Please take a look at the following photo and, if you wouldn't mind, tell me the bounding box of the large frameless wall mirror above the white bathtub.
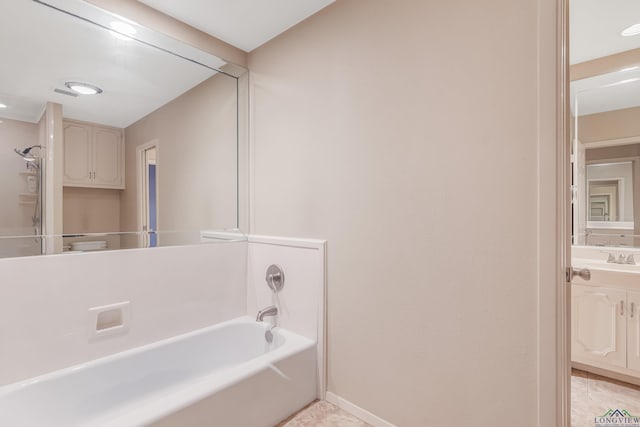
[0,0,246,257]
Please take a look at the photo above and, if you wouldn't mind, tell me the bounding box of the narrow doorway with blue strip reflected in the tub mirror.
[138,141,159,248]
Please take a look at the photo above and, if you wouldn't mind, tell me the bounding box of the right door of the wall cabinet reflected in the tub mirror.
[93,127,123,188]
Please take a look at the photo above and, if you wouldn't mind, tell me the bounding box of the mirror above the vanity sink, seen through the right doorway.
[571,37,640,247]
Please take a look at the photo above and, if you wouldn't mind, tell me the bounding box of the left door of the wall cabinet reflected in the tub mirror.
[63,123,93,186]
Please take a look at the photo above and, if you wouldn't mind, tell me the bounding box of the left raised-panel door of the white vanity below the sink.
[571,285,627,368]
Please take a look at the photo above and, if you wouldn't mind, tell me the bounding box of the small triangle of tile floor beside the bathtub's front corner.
[276,401,371,427]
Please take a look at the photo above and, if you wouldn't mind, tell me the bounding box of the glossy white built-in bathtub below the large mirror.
[0,317,317,427]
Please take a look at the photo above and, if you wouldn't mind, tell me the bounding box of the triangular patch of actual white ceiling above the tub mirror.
[138,0,335,52]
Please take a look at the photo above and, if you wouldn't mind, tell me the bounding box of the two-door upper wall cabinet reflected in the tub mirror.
[63,121,124,189]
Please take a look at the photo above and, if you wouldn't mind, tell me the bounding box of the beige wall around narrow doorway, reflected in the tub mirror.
[120,74,238,239]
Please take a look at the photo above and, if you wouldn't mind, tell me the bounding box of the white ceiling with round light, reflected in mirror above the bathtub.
[0,0,223,127]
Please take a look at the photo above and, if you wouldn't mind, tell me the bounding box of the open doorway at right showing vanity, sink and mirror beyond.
[562,0,640,427]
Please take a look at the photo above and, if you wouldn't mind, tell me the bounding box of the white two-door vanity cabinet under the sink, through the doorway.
[571,284,640,376]
